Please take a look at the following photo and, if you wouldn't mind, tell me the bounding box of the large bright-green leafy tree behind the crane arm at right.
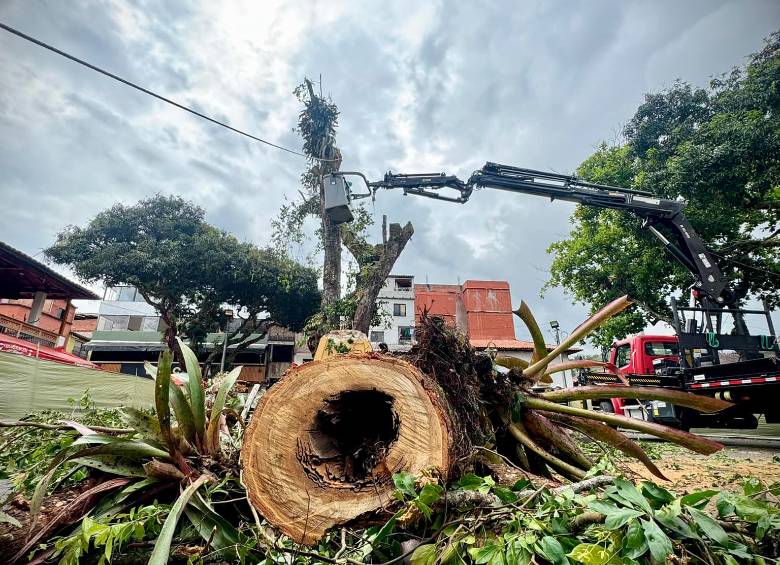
[546,33,780,346]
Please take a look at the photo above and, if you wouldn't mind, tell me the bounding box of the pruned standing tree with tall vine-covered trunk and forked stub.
[274,80,414,337]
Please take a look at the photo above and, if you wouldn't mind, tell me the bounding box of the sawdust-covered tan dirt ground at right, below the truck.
[621,444,780,493]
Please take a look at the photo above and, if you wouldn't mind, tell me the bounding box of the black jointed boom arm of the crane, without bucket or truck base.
[370,163,733,306]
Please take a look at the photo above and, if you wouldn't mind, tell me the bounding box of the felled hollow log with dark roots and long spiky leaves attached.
[241,298,731,545]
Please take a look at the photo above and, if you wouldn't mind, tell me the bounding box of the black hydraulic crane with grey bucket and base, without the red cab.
[324,162,780,426]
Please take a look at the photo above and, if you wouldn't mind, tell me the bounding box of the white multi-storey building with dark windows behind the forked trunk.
[368,275,414,351]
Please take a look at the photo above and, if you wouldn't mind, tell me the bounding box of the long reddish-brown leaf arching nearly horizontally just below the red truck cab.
[541,385,733,414]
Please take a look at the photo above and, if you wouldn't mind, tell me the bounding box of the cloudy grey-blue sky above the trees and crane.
[0,0,780,342]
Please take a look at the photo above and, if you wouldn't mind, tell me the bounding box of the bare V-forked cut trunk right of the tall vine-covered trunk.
[344,216,414,335]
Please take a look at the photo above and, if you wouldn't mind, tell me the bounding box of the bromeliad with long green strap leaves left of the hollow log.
[12,341,248,565]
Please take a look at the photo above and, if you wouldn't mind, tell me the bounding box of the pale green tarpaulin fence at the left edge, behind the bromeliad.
[0,353,154,420]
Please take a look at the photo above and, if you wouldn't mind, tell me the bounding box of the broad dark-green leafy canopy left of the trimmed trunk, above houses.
[46,195,319,366]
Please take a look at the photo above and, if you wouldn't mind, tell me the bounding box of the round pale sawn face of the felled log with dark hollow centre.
[241,354,456,544]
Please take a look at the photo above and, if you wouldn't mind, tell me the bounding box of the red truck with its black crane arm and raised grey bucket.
[322,162,780,428]
